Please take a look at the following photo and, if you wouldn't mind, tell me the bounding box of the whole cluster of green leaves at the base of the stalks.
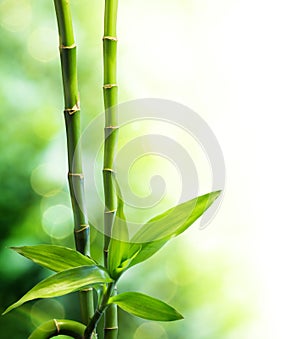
[3,189,220,321]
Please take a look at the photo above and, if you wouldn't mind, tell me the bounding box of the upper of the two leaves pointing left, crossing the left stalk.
[11,245,96,272]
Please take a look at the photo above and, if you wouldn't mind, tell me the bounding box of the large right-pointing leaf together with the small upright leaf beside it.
[108,191,221,278]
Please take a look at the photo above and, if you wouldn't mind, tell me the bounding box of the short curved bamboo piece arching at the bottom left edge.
[28,319,85,339]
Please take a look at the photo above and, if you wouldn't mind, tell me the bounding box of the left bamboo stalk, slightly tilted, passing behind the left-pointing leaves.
[54,0,94,324]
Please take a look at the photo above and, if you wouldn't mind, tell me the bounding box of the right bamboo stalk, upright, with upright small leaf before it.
[103,0,118,339]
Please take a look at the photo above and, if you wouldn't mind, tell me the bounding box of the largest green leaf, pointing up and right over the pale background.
[128,191,221,267]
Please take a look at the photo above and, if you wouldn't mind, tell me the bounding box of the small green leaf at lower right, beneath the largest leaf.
[109,292,183,321]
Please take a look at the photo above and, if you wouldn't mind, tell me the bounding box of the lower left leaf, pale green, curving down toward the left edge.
[3,266,112,314]
